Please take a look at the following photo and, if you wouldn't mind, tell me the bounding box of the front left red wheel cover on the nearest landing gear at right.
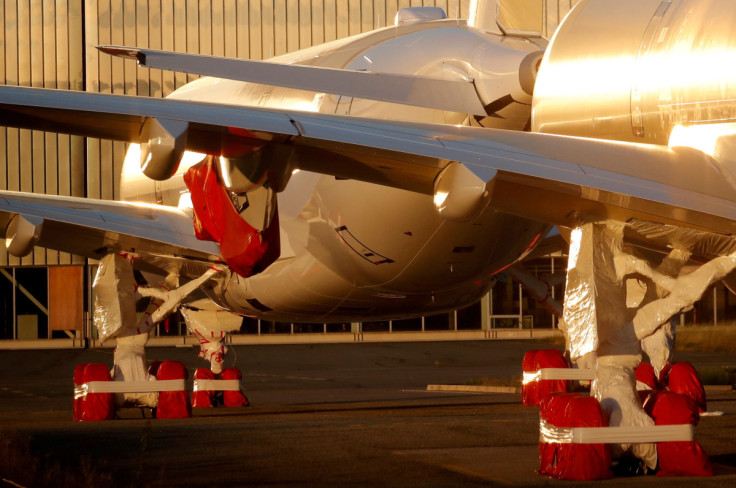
[539,393,613,480]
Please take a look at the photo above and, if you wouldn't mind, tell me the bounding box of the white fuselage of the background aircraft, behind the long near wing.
[121,21,549,322]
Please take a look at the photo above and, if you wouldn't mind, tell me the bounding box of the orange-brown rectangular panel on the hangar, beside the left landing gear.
[49,266,84,330]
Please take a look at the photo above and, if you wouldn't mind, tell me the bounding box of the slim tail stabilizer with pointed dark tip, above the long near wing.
[98,46,487,115]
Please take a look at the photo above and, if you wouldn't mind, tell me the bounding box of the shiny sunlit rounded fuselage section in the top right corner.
[532,0,736,144]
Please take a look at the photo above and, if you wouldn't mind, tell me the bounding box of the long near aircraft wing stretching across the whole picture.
[0,86,736,260]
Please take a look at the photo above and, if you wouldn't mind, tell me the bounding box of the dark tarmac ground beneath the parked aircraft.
[0,341,736,487]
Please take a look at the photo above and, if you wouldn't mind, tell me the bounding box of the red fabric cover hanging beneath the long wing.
[184,157,281,278]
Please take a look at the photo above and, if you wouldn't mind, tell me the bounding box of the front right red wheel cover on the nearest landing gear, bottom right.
[644,391,713,476]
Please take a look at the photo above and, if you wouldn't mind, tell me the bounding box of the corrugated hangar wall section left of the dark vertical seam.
[0,0,84,265]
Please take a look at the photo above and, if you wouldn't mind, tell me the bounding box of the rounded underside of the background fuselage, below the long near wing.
[216,173,548,322]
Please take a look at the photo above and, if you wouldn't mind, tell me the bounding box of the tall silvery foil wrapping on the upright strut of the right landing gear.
[564,221,657,468]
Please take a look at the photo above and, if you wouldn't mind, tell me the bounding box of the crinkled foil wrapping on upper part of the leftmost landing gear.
[92,254,137,342]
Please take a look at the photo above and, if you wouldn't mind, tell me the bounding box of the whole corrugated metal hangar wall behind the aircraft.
[0,0,577,266]
